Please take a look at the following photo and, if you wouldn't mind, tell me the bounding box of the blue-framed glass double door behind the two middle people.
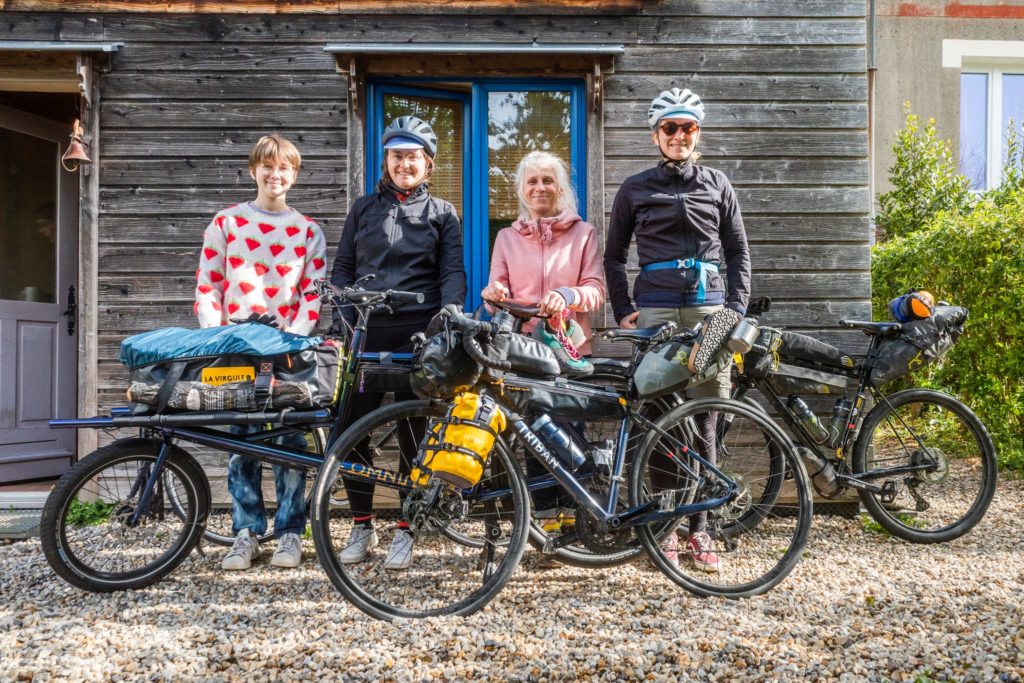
[365,78,587,307]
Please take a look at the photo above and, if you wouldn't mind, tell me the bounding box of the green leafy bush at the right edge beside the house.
[871,117,1024,471]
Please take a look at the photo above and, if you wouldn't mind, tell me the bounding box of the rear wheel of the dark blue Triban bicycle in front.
[630,398,811,598]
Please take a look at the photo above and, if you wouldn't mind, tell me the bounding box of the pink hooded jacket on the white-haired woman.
[487,213,605,354]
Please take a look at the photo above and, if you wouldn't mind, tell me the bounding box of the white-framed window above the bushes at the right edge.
[959,67,1024,190]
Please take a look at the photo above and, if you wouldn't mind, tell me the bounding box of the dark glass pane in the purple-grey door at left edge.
[0,128,59,303]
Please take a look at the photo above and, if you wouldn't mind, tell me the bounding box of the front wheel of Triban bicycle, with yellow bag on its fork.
[311,400,529,620]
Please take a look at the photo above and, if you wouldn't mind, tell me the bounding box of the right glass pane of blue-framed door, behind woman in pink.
[487,90,571,253]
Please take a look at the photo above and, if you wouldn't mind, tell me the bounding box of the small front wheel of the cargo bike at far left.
[39,438,210,593]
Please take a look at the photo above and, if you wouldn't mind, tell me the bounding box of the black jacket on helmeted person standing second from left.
[331,184,466,326]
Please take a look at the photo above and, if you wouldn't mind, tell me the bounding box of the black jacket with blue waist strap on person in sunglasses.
[604,163,751,321]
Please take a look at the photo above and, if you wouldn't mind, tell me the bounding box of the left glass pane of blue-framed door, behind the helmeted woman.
[383,93,463,218]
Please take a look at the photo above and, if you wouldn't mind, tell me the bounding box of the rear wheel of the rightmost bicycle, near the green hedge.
[853,389,996,543]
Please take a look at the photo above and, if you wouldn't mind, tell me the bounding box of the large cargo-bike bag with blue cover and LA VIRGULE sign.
[120,323,342,414]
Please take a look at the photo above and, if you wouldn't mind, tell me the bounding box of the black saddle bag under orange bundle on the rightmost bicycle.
[871,305,968,386]
